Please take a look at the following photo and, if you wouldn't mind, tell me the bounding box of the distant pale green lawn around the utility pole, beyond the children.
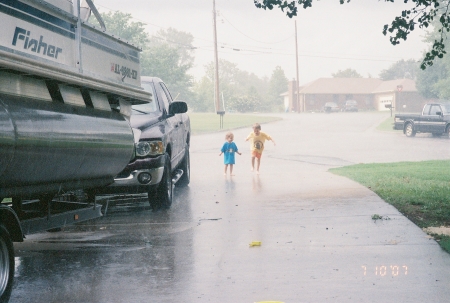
[189,113,282,135]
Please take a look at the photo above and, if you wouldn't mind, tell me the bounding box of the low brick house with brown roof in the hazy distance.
[281,78,427,112]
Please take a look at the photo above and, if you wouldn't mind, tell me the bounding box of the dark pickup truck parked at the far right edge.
[394,103,450,137]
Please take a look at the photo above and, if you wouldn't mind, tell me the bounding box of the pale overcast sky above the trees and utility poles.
[95,0,427,84]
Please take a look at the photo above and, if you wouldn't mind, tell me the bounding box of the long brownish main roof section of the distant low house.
[300,78,383,94]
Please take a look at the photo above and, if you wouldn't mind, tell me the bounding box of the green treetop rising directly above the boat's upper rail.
[96,11,149,47]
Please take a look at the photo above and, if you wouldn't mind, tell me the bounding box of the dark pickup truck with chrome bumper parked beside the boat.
[91,76,191,209]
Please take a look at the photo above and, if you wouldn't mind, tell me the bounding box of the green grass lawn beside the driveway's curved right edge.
[330,160,450,252]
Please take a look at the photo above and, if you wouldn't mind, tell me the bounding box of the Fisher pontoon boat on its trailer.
[0,0,154,302]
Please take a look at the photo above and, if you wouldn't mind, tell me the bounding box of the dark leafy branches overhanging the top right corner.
[253,0,450,69]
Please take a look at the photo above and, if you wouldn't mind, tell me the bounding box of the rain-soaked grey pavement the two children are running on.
[11,113,450,303]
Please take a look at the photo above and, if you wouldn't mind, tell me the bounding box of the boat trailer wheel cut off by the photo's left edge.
[0,225,15,302]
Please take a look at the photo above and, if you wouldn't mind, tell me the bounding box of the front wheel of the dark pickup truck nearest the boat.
[148,153,173,210]
